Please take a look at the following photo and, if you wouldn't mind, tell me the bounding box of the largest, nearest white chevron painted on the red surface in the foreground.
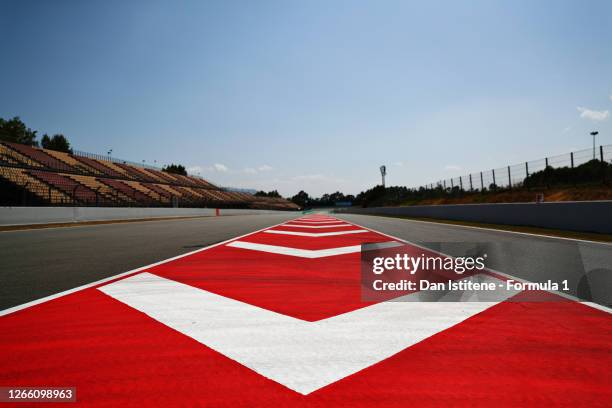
[98,273,513,395]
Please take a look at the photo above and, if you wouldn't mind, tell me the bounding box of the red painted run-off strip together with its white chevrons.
[0,214,612,407]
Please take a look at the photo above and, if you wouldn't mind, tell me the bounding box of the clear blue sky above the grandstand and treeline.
[0,0,612,195]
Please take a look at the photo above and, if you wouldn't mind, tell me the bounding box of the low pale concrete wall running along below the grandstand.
[0,207,296,226]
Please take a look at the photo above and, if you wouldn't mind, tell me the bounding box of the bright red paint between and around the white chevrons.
[0,217,612,407]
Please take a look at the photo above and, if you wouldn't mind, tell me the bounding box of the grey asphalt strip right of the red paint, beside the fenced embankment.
[340,214,612,306]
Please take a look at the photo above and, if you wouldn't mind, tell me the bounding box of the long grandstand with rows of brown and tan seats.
[0,141,298,210]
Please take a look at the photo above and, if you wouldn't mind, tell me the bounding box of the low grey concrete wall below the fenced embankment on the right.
[337,201,612,233]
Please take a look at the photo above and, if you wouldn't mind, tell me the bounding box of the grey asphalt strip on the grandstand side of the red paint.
[0,214,296,310]
